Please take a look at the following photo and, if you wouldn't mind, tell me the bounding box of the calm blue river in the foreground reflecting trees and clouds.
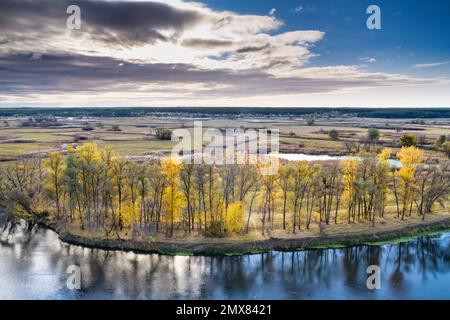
[0,222,450,299]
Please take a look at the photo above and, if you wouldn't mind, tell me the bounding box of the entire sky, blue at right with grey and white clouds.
[0,0,450,107]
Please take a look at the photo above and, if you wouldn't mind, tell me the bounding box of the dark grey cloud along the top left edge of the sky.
[0,0,203,45]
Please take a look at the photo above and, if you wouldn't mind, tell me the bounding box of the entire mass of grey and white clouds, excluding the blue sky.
[0,0,441,106]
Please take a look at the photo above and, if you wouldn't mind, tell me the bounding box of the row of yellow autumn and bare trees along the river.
[0,142,450,238]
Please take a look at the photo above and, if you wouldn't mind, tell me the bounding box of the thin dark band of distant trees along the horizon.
[0,107,450,119]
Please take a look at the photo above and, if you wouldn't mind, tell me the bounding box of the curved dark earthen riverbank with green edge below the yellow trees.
[39,216,450,256]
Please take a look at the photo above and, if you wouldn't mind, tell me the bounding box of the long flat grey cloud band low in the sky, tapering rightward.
[0,54,427,97]
